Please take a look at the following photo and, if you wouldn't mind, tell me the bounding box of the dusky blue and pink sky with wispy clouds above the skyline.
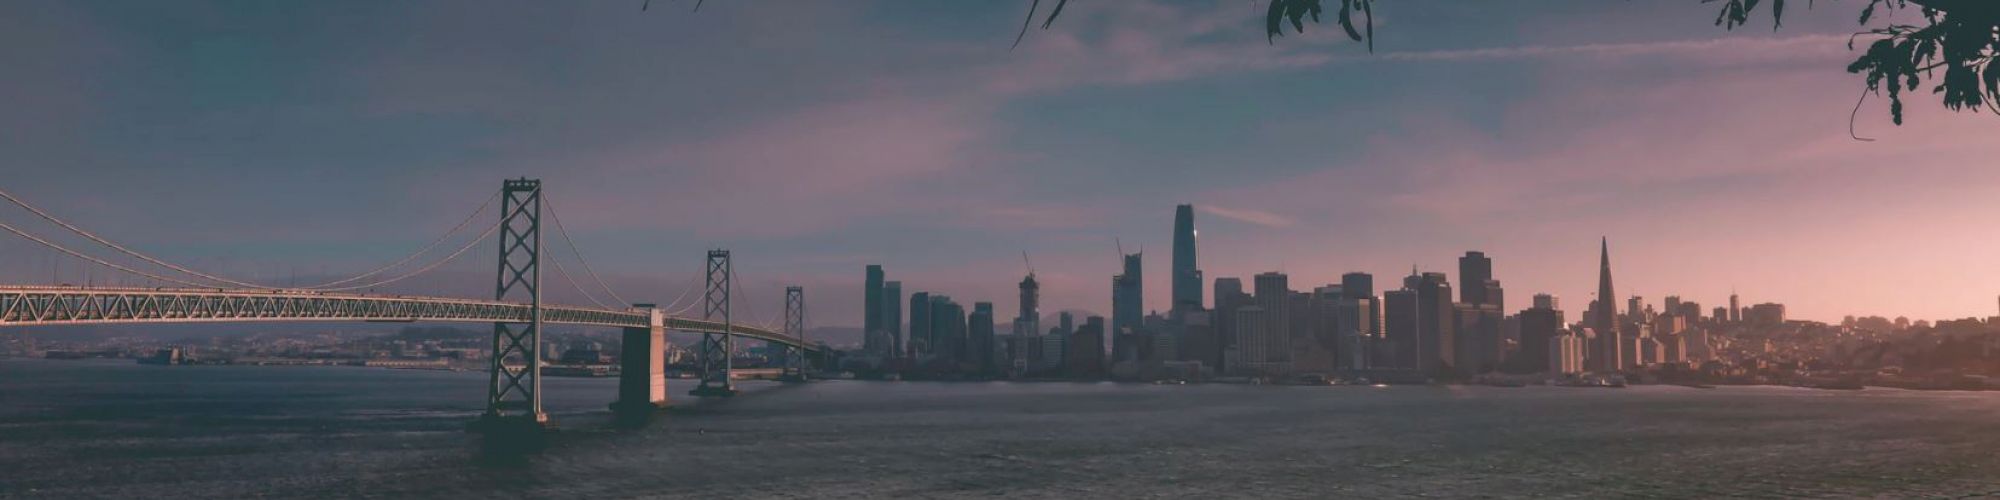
[0,0,2000,326]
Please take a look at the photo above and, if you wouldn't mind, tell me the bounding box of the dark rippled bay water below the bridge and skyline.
[0,360,2000,498]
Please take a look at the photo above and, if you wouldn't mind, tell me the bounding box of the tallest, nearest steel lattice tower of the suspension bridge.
[480,178,548,430]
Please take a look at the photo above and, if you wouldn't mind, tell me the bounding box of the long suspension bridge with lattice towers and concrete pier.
[0,178,822,430]
